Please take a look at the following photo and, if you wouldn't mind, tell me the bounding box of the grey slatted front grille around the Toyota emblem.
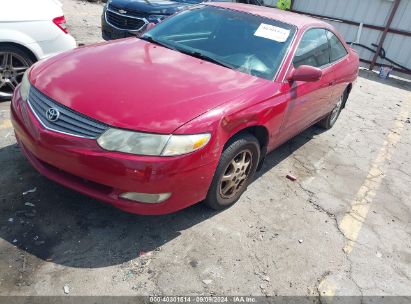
[28,86,108,138]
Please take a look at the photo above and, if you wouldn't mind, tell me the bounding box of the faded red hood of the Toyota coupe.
[29,38,273,133]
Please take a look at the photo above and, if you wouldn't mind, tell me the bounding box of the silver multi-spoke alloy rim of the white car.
[0,52,31,98]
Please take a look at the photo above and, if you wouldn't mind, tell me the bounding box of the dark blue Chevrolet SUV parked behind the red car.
[101,0,263,40]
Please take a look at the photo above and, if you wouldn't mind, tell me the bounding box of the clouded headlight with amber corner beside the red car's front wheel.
[97,129,210,156]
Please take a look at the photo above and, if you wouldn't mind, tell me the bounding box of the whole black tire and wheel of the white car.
[0,45,35,101]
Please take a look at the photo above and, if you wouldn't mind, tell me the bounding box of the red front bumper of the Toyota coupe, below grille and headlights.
[11,89,218,214]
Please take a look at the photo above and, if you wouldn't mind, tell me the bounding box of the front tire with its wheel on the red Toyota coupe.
[204,133,260,210]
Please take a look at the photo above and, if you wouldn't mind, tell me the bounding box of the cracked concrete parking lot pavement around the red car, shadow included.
[0,0,411,300]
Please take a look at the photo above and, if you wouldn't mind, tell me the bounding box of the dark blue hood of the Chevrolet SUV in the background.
[110,0,192,15]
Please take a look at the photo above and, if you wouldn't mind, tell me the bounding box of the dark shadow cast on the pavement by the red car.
[0,127,321,268]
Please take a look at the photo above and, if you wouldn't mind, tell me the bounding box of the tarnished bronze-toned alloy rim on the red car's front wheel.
[219,150,253,199]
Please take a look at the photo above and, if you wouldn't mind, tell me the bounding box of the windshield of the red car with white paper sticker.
[142,5,296,80]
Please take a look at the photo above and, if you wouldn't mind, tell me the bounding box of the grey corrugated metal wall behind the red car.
[266,0,411,73]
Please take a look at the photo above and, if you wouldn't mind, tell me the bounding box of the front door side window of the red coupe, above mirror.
[293,29,330,68]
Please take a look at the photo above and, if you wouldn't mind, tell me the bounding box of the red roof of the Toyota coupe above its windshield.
[207,2,334,30]
